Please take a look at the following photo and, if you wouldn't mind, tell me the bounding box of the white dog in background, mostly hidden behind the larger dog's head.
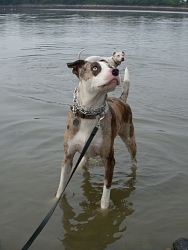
[78,49,125,68]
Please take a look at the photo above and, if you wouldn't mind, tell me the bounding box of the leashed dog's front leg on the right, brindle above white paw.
[101,152,115,209]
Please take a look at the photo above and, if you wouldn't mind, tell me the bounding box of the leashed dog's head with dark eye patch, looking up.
[67,60,120,92]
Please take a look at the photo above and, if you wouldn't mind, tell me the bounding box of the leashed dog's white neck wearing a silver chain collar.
[72,86,107,116]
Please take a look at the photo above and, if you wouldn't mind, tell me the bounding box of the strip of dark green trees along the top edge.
[0,0,188,6]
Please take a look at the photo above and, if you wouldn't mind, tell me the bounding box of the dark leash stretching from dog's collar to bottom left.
[21,116,104,250]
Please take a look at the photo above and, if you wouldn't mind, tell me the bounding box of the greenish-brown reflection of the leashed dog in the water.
[59,168,136,250]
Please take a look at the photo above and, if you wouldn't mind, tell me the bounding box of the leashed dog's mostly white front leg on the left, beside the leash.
[56,154,73,198]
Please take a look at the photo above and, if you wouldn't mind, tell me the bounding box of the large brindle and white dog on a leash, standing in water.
[56,60,137,209]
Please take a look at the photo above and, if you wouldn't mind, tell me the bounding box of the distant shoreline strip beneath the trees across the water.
[0,4,188,12]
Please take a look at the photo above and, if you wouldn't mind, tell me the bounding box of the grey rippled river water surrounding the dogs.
[0,8,188,250]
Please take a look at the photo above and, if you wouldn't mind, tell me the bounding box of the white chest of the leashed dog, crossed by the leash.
[68,119,103,157]
